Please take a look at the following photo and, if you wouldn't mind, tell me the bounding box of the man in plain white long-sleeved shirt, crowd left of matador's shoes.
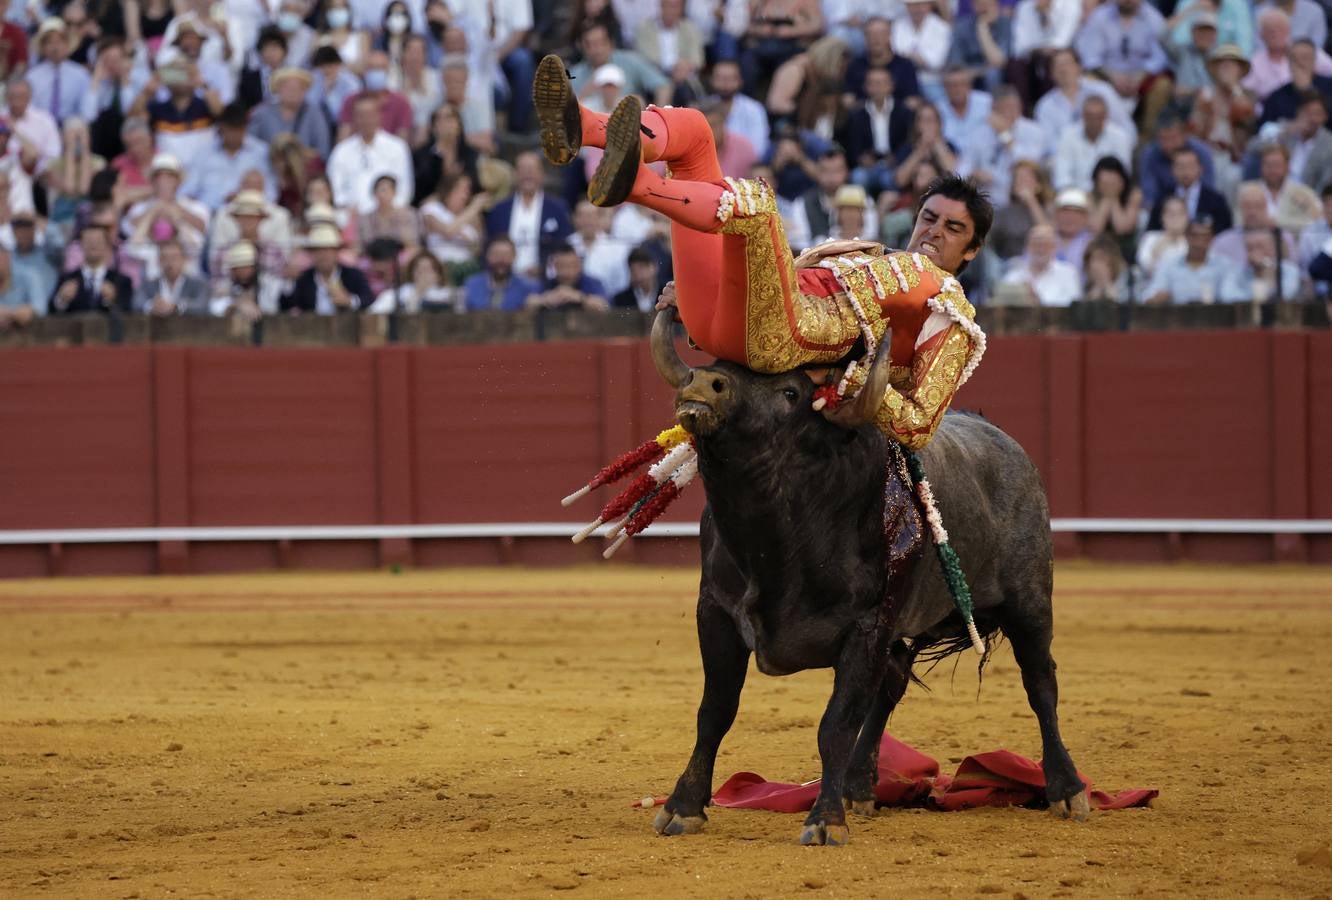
[328,93,414,213]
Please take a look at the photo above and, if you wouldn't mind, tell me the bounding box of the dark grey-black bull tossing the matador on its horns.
[653,310,1087,844]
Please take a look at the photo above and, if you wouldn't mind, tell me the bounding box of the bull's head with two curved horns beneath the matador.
[651,309,890,438]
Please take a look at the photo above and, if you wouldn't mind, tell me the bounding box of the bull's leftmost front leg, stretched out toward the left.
[653,602,750,835]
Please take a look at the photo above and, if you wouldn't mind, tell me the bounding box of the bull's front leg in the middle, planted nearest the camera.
[801,635,882,845]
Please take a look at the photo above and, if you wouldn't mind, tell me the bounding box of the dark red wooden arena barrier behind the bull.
[0,332,1332,576]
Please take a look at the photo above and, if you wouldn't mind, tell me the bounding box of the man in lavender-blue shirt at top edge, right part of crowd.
[1076,0,1172,126]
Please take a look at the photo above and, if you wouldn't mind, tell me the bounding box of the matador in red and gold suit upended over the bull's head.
[534,56,994,449]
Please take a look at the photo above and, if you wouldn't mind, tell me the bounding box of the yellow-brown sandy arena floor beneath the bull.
[0,564,1332,899]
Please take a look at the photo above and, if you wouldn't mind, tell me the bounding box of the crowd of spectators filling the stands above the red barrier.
[0,0,1332,328]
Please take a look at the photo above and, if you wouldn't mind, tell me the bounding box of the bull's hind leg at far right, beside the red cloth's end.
[1003,614,1090,821]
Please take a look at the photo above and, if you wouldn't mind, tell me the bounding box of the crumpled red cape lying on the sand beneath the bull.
[658,735,1159,812]
